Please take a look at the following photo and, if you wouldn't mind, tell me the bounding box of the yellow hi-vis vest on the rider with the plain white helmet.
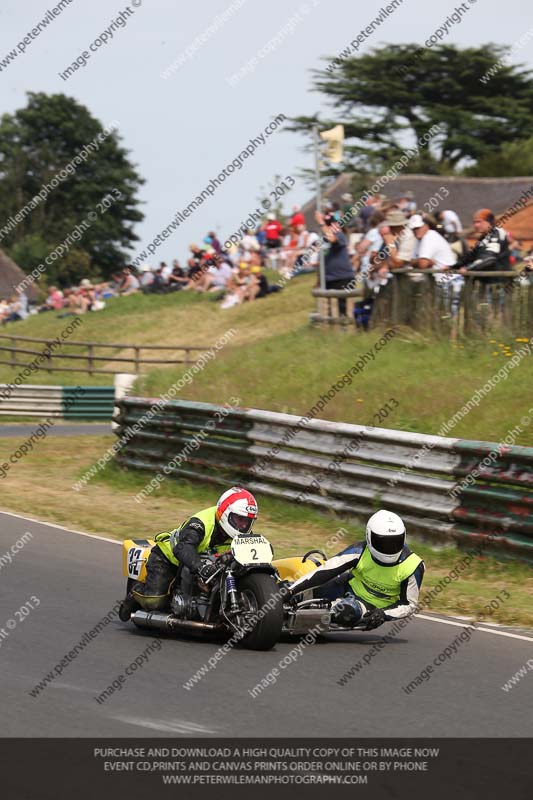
[350,547,422,608]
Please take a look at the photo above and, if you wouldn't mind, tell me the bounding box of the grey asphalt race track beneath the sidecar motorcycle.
[0,513,533,737]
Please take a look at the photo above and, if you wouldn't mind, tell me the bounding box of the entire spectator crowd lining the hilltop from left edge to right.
[0,192,533,329]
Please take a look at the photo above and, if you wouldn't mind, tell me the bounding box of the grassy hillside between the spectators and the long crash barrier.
[0,276,533,445]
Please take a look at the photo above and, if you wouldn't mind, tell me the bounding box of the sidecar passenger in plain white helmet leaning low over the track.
[289,510,424,630]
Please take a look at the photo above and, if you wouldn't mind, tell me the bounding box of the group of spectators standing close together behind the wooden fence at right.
[315,192,533,330]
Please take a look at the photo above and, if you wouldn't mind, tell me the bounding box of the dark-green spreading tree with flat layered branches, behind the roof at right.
[292,44,533,174]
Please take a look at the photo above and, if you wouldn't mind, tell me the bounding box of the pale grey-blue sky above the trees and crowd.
[0,0,533,264]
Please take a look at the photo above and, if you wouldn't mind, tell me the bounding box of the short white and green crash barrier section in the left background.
[0,384,115,420]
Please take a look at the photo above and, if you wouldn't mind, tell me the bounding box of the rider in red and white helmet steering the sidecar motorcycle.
[119,486,257,622]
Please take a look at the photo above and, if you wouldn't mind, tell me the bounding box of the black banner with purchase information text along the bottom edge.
[0,738,533,800]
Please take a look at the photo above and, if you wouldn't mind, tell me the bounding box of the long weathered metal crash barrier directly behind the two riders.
[114,397,533,559]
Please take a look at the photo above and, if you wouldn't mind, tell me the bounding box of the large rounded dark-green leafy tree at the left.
[0,93,144,285]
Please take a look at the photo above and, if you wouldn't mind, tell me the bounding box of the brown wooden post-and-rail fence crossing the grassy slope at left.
[0,333,208,375]
